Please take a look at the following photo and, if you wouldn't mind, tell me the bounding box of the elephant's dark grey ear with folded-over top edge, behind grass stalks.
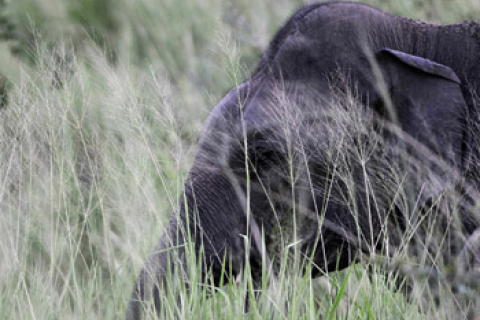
[375,49,466,201]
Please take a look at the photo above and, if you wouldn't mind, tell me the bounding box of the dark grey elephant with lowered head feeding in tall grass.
[127,2,480,320]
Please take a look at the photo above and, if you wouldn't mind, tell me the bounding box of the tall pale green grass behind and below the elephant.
[0,0,480,320]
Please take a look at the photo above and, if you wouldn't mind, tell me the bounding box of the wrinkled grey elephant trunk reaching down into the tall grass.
[127,167,253,320]
